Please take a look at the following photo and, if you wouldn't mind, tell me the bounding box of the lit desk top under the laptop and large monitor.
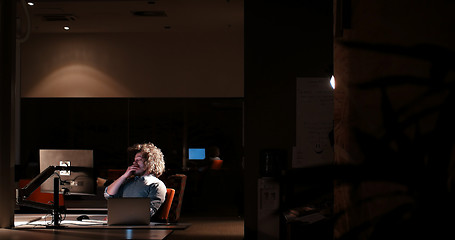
[12,214,190,240]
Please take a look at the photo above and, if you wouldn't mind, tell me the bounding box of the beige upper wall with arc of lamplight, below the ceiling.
[21,29,243,97]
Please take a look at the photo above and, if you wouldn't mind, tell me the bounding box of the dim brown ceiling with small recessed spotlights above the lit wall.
[17,0,243,33]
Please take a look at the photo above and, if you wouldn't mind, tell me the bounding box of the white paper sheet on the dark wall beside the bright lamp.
[292,78,333,168]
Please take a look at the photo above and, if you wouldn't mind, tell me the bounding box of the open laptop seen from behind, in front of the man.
[107,198,150,225]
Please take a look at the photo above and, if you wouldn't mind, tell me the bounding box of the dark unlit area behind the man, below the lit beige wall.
[15,98,243,216]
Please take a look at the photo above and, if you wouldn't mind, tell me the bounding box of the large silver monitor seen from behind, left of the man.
[39,149,96,195]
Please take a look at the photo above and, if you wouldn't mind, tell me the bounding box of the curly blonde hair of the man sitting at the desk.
[128,142,165,177]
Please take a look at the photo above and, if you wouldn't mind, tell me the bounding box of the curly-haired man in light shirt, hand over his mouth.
[104,143,166,217]
